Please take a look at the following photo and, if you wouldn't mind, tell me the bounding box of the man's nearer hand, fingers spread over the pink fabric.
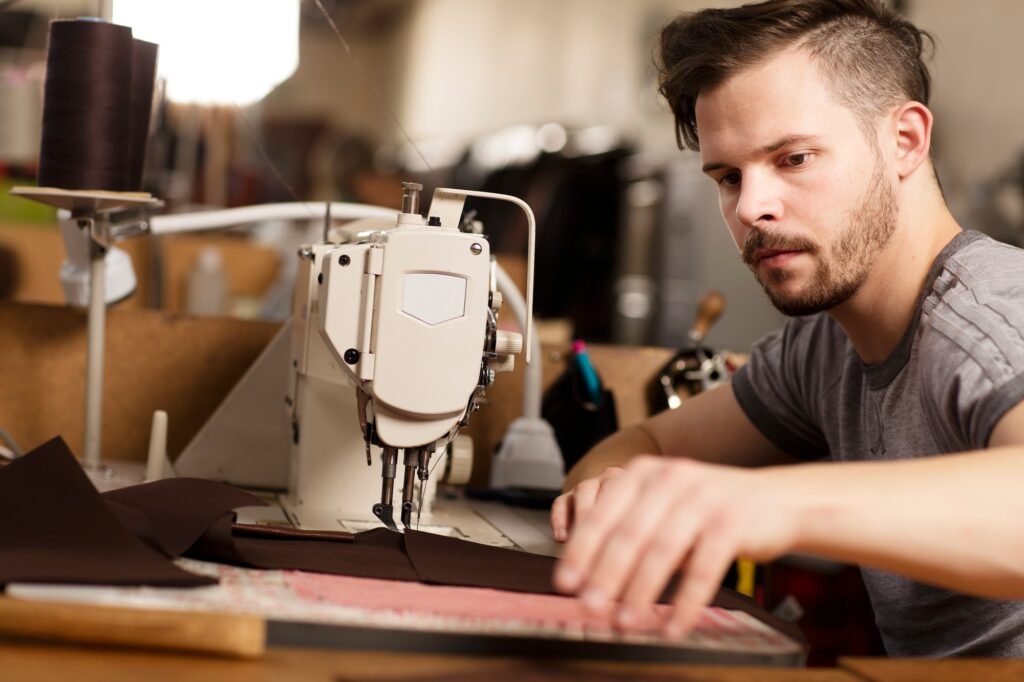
[552,457,801,637]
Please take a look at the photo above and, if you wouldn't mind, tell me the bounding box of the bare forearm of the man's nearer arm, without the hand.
[774,447,1024,598]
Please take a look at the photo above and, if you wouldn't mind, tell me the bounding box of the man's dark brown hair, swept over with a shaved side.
[656,0,934,150]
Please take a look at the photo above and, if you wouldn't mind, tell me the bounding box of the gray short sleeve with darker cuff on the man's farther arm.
[732,318,828,460]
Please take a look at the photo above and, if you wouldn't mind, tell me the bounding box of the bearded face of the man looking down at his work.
[696,49,897,315]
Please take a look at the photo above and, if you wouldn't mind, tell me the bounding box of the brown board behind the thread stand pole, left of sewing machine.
[0,303,279,460]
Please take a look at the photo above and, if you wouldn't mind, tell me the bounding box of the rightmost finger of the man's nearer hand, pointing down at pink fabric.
[665,526,735,639]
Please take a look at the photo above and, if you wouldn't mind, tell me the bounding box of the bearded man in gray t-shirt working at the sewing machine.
[552,0,1024,656]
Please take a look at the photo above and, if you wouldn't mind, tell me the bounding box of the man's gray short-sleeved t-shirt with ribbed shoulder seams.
[733,231,1024,656]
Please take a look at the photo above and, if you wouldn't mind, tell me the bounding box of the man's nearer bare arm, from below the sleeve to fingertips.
[555,403,1024,635]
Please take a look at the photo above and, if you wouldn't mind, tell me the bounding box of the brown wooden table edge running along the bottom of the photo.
[0,640,1024,682]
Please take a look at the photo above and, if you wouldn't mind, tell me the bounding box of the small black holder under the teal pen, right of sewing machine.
[541,356,618,471]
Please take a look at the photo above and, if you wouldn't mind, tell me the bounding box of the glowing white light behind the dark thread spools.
[113,0,299,105]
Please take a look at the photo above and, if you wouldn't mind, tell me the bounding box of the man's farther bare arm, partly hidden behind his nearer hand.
[551,384,796,542]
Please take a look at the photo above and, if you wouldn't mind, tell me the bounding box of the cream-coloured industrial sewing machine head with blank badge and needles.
[290,183,523,528]
